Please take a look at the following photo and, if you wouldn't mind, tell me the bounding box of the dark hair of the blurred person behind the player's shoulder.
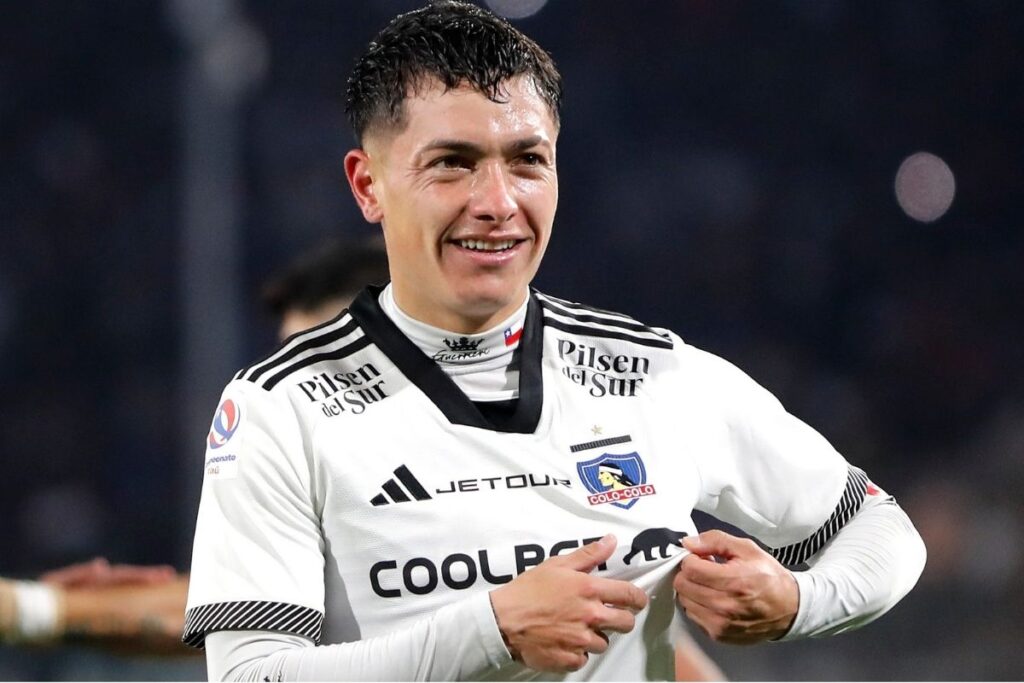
[261,240,389,317]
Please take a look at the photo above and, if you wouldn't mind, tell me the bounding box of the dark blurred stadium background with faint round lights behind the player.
[0,0,1024,680]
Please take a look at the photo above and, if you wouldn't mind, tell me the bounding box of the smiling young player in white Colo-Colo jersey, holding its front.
[185,2,925,680]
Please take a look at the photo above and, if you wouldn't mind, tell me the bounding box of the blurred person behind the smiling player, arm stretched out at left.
[0,239,388,655]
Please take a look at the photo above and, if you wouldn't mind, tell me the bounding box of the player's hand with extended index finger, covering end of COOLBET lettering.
[490,535,647,672]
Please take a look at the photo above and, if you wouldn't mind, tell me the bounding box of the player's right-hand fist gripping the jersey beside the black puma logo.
[673,529,800,645]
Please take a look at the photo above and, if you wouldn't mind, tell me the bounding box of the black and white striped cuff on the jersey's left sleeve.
[181,600,324,649]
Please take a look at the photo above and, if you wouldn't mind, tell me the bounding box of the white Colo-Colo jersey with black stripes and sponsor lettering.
[184,290,920,680]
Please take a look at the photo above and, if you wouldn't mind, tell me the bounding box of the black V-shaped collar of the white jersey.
[348,285,544,434]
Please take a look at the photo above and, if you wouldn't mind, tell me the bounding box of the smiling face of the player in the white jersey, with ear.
[345,77,558,334]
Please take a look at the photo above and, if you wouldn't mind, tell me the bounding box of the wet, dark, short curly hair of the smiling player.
[345,0,562,145]
